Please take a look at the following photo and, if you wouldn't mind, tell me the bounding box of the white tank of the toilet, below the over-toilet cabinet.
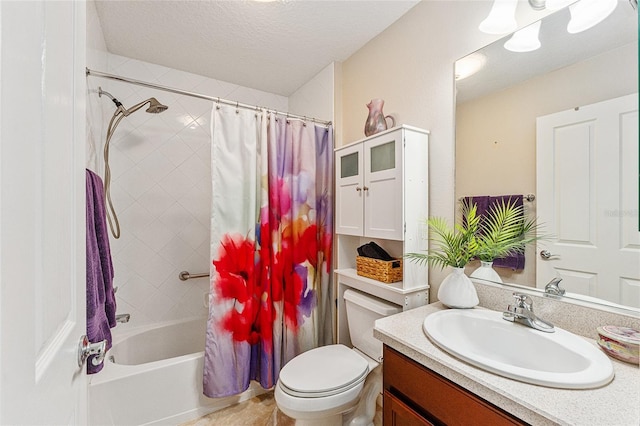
[344,289,402,361]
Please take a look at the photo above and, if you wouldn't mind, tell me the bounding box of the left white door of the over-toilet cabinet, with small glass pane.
[336,143,364,236]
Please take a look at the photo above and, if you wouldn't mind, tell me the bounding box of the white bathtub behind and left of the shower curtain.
[89,317,265,426]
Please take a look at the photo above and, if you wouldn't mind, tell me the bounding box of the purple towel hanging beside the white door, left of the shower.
[86,170,116,374]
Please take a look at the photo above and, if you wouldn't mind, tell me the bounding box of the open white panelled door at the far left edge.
[0,1,87,425]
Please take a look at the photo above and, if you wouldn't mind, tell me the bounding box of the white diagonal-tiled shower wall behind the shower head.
[88,54,288,328]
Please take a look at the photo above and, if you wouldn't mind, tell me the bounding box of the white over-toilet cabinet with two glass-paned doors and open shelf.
[335,125,429,345]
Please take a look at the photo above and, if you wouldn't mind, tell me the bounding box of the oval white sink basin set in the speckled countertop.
[422,309,613,389]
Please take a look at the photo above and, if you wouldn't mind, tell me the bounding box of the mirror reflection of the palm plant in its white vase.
[471,199,542,282]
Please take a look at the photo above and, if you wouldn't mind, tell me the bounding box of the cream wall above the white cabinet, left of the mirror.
[336,0,548,301]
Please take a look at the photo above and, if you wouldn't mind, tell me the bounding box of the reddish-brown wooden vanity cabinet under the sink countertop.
[382,345,527,426]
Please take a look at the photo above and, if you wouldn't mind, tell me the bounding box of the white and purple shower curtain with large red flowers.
[204,105,333,397]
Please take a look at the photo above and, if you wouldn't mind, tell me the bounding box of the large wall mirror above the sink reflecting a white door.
[456,1,640,311]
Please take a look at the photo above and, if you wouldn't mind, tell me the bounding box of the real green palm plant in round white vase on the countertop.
[406,203,480,308]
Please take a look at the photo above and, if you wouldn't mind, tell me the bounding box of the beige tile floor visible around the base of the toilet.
[181,392,382,426]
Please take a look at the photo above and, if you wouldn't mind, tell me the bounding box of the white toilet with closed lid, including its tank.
[274,289,402,426]
